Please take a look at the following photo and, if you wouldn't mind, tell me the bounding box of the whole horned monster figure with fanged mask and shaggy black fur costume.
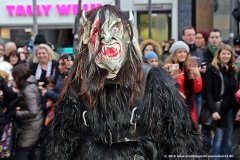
[41,5,203,160]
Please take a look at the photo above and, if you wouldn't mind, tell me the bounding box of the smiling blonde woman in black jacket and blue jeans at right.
[204,45,238,160]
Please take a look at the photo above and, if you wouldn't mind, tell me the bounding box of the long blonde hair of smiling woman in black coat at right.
[211,44,238,74]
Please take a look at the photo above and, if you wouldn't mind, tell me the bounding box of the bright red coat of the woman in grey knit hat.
[176,71,202,123]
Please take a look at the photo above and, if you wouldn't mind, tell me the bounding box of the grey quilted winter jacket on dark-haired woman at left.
[16,75,44,147]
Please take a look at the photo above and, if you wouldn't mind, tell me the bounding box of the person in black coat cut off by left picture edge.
[0,75,12,138]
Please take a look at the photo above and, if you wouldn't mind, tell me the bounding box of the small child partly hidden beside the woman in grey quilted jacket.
[43,76,56,126]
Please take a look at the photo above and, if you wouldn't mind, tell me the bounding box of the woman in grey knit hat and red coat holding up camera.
[163,41,202,123]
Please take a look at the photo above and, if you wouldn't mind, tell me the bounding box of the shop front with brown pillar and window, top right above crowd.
[195,0,239,44]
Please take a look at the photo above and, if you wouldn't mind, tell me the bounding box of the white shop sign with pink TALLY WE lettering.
[0,0,109,25]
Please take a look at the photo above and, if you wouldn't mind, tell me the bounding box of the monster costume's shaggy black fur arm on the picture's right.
[141,68,203,159]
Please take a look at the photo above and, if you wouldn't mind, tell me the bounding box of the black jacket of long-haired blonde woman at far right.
[204,64,237,128]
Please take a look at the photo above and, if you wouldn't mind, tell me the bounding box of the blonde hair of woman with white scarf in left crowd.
[33,44,56,63]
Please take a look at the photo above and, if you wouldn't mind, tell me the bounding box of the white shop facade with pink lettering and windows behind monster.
[0,0,182,51]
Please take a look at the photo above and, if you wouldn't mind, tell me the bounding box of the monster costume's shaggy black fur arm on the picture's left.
[40,79,83,160]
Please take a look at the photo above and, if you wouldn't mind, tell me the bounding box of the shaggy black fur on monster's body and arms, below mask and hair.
[41,68,204,160]
